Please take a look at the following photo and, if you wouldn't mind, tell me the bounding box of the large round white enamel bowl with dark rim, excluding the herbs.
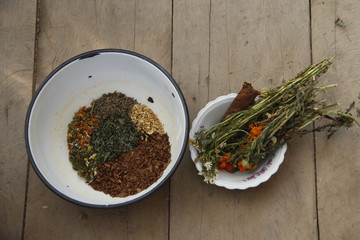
[25,49,189,208]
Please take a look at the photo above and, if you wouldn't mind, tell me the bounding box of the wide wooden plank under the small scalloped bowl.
[170,1,317,239]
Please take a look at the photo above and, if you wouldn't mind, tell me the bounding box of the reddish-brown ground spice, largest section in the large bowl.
[90,133,171,197]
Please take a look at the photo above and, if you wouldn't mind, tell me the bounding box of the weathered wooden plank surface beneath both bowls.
[0,0,360,240]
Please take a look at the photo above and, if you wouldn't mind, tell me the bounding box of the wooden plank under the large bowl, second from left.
[25,0,172,240]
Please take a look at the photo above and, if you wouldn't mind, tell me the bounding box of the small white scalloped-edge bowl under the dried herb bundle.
[189,93,287,190]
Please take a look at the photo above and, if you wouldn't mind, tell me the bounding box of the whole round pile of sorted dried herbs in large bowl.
[67,92,171,197]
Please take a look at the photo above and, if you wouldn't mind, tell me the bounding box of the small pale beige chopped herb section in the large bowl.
[130,104,165,134]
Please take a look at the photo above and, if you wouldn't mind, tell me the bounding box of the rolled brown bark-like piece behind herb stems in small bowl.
[221,82,260,121]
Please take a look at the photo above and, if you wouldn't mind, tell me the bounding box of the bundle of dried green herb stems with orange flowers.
[190,59,360,183]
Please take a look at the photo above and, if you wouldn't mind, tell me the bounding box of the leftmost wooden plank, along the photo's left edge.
[0,0,36,239]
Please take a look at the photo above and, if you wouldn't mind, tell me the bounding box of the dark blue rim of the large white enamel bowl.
[24,48,190,208]
